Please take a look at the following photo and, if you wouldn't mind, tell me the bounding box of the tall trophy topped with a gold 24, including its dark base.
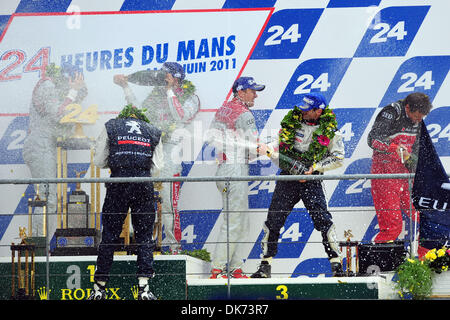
[52,104,100,255]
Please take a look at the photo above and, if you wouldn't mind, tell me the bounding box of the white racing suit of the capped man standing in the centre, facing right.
[208,97,258,272]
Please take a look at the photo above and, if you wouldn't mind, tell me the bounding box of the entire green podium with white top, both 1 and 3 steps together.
[0,255,404,301]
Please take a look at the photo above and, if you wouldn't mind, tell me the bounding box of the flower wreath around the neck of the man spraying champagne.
[279,106,337,165]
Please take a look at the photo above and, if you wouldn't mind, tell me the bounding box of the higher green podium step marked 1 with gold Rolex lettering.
[0,255,210,300]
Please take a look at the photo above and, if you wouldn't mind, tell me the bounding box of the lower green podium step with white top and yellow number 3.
[187,276,395,300]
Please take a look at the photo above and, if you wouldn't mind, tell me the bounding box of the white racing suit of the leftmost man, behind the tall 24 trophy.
[23,78,87,238]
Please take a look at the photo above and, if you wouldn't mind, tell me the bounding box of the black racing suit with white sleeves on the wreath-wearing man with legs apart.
[262,121,345,262]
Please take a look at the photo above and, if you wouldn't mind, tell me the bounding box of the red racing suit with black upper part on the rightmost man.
[367,100,420,243]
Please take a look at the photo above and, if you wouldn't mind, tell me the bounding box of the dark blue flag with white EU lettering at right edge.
[413,121,450,249]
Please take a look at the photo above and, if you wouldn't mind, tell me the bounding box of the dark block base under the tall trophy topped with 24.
[51,228,100,256]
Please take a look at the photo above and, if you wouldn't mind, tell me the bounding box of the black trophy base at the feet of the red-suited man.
[358,241,406,276]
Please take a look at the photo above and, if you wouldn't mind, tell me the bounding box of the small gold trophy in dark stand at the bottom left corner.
[10,228,36,300]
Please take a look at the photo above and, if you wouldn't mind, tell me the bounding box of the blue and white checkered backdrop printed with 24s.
[0,0,450,273]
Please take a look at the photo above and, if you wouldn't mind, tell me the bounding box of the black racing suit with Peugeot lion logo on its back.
[94,118,161,282]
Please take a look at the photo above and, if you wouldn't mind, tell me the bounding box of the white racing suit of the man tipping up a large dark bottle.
[124,86,200,251]
